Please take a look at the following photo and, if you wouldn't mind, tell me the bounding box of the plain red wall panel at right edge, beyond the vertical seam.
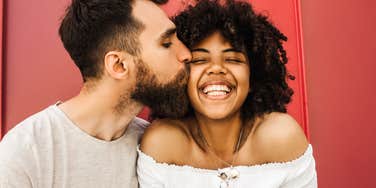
[302,0,376,188]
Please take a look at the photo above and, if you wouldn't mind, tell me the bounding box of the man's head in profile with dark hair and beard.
[59,0,191,117]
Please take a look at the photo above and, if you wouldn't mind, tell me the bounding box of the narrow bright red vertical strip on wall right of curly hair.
[294,0,310,139]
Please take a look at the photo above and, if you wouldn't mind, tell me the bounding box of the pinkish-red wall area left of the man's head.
[2,0,81,133]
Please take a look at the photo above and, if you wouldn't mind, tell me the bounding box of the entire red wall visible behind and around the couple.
[0,0,376,188]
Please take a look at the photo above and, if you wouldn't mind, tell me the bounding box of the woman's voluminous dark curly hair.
[173,0,294,120]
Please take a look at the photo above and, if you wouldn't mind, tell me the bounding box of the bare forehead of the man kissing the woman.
[132,0,175,33]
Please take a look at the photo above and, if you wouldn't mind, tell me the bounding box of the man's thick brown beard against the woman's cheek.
[131,60,189,119]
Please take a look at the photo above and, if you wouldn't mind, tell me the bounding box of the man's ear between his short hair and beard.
[104,51,132,79]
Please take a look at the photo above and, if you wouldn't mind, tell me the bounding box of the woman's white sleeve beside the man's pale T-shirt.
[137,149,166,188]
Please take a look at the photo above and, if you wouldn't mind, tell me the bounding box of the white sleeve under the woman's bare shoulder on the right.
[281,146,317,188]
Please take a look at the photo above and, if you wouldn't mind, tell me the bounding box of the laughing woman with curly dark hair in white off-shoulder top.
[138,1,317,188]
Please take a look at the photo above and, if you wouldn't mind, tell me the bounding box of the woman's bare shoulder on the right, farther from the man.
[252,112,308,162]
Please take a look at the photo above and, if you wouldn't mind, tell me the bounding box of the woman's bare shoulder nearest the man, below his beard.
[140,119,190,164]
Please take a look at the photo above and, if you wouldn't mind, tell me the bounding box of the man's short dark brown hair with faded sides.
[59,0,168,82]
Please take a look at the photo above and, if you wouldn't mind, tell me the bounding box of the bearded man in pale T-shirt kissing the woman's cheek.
[0,0,191,188]
